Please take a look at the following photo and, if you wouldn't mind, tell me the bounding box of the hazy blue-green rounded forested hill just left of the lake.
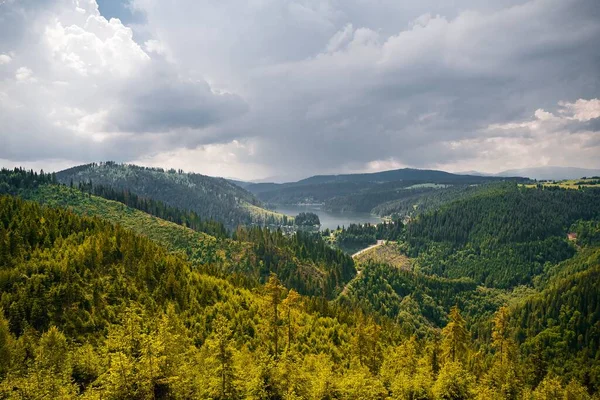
[56,162,283,228]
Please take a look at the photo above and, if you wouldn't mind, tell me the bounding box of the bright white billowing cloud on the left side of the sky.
[0,0,246,162]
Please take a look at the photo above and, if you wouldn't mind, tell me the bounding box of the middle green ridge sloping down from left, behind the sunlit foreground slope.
[0,170,356,298]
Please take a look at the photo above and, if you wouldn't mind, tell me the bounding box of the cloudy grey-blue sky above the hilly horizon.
[0,0,600,180]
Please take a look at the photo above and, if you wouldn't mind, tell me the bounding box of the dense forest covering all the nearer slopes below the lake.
[0,166,600,400]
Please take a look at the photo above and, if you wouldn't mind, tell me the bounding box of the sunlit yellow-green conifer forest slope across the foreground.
[0,196,600,400]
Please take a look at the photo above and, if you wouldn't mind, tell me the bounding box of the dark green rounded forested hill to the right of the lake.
[406,184,600,287]
